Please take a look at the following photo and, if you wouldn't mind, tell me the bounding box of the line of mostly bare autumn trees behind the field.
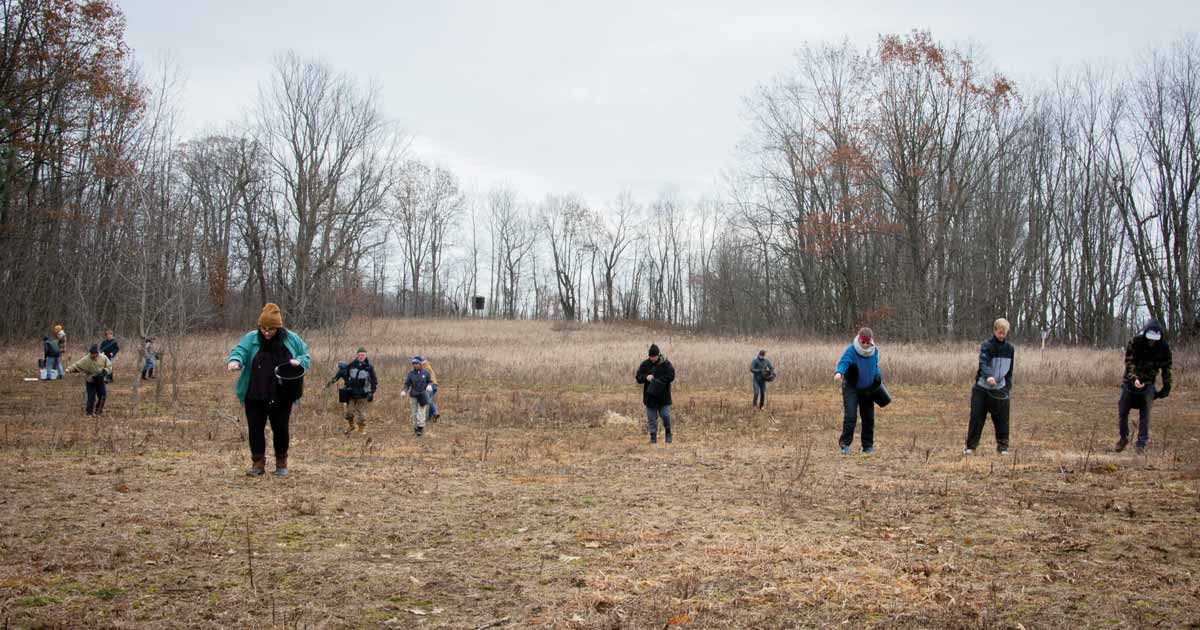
[0,0,1200,344]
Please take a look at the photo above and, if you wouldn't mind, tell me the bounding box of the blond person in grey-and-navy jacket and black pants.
[962,317,1015,455]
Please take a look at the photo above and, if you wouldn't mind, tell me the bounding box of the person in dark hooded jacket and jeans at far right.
[1114,319,1171,455]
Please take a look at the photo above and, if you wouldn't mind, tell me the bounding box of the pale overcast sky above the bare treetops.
[118,0,1200,204]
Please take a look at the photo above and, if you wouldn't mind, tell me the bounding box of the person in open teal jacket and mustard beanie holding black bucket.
[226,302,310,476]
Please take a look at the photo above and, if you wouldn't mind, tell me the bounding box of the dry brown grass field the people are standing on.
[0,320,1200,630]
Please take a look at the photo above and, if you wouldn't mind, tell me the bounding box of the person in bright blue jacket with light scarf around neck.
[833,328,883,455]
